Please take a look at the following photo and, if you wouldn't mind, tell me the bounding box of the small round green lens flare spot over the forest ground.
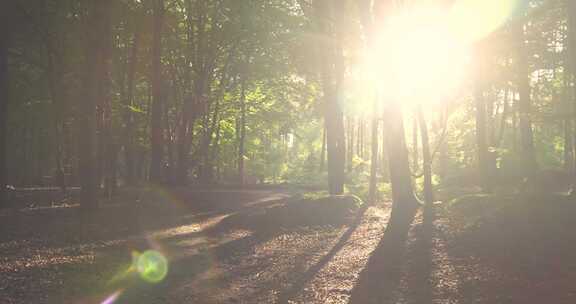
[134,250,168,283]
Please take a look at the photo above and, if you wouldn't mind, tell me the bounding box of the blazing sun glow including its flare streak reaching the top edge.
[362,0,517,104]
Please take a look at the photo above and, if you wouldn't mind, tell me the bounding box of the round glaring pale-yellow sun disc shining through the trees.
[367,8,470,104]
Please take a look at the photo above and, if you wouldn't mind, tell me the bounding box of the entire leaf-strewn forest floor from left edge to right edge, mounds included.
[0,189,576,304]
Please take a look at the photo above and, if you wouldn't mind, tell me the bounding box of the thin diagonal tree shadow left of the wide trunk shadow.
[278,205,368,304]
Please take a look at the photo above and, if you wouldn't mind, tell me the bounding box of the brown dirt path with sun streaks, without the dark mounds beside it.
[0,190,576,304]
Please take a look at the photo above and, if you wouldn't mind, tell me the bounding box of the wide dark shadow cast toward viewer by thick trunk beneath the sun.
[349,205,417,304]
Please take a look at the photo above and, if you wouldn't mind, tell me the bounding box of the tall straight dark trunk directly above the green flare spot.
[150,0,164,183]
